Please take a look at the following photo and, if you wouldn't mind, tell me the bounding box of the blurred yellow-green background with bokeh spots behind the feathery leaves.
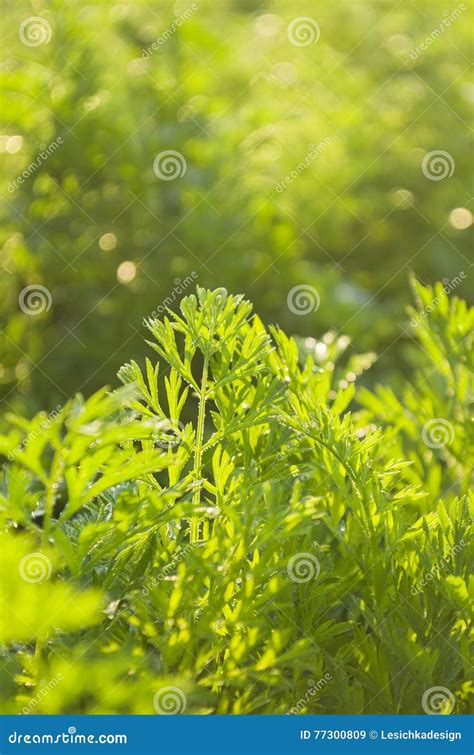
[0,0,474,410]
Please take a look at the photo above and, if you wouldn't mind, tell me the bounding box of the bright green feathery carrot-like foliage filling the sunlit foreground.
[0,284,474,714]
